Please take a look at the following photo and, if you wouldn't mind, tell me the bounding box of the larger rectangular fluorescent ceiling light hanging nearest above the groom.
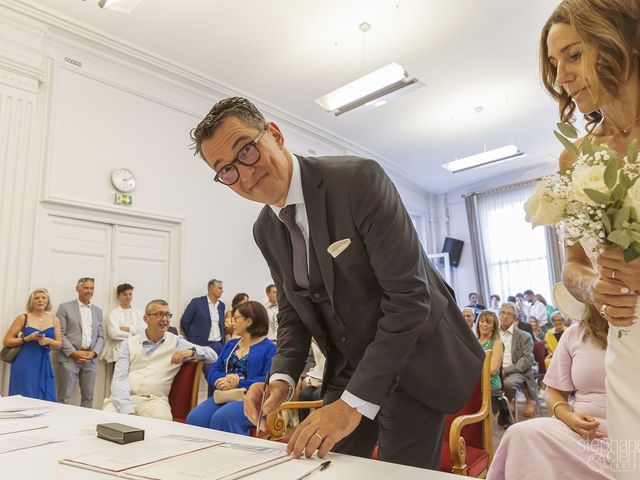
[316,63,424,115]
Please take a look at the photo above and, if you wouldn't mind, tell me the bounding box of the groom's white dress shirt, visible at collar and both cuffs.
[269,155,380,420]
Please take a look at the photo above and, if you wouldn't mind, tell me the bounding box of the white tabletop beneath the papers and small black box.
[0,396,460,480]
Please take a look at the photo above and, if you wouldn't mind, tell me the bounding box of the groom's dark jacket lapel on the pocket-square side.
[298,157,333,302]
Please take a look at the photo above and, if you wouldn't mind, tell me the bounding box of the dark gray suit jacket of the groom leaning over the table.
[253,157,484,412]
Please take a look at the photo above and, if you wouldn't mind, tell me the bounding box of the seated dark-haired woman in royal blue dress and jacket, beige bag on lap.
[187,301,276,435]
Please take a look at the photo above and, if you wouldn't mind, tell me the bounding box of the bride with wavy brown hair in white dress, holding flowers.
[540,0,640,480]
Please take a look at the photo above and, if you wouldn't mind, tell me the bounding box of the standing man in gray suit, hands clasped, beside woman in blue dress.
[56,277,104,408]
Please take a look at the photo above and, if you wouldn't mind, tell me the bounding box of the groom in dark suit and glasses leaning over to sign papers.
[191,97,484,468]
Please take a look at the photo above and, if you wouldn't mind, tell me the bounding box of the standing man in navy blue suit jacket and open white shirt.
[180,278,224,396]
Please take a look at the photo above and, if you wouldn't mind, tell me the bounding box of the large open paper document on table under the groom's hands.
[60,435,291,480]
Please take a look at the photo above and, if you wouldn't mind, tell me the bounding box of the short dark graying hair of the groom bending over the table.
[190,97,267,159]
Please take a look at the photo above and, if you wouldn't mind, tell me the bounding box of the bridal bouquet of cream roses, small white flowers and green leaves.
[524,123,640,262]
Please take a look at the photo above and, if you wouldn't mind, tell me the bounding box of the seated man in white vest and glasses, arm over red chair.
[103,300,218,420]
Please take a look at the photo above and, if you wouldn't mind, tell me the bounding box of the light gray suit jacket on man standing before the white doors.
[56,300,104,361]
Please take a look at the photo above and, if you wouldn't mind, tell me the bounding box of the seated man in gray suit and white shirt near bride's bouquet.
[498,303,538,427]
